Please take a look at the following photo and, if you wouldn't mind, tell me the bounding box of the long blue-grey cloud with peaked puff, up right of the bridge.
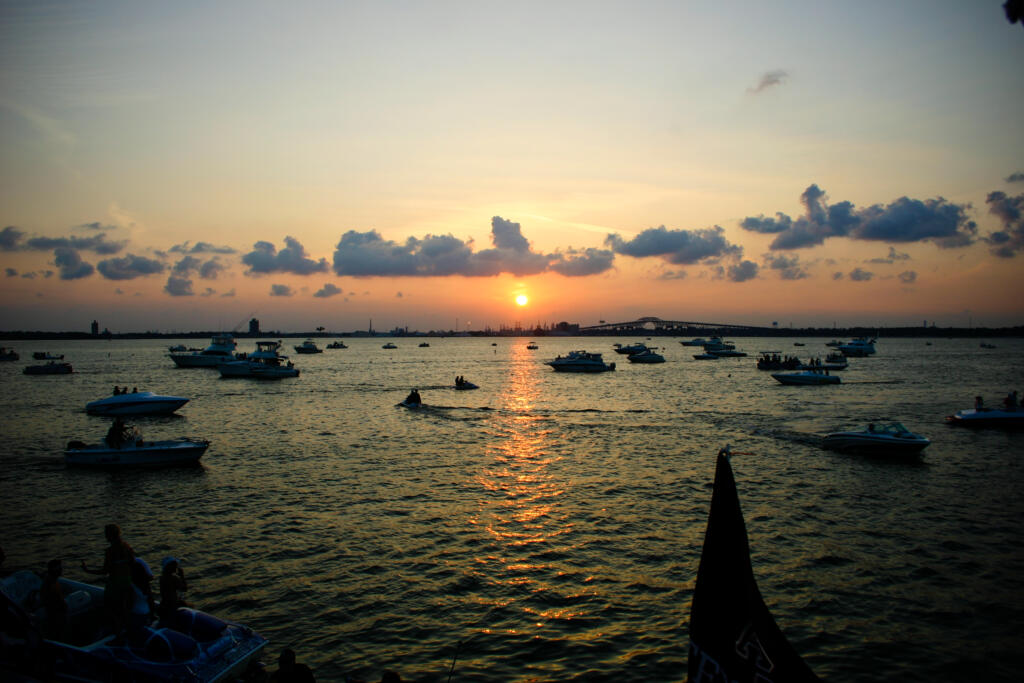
[740,184,978,250]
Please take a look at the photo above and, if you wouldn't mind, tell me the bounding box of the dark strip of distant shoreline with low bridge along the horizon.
[0,326,1024,342]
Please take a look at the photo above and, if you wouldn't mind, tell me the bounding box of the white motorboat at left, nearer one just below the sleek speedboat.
[65,431,210,467]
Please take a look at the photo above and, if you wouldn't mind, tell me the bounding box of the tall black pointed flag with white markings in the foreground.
[687,446,820,683]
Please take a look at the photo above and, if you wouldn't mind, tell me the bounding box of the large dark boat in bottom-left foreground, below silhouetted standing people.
[0,569,267,683]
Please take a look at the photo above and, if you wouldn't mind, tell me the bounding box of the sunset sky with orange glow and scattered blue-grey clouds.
[0,0,1024,332]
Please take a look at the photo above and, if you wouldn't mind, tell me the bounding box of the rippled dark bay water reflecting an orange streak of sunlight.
[0,338,1024,681]
